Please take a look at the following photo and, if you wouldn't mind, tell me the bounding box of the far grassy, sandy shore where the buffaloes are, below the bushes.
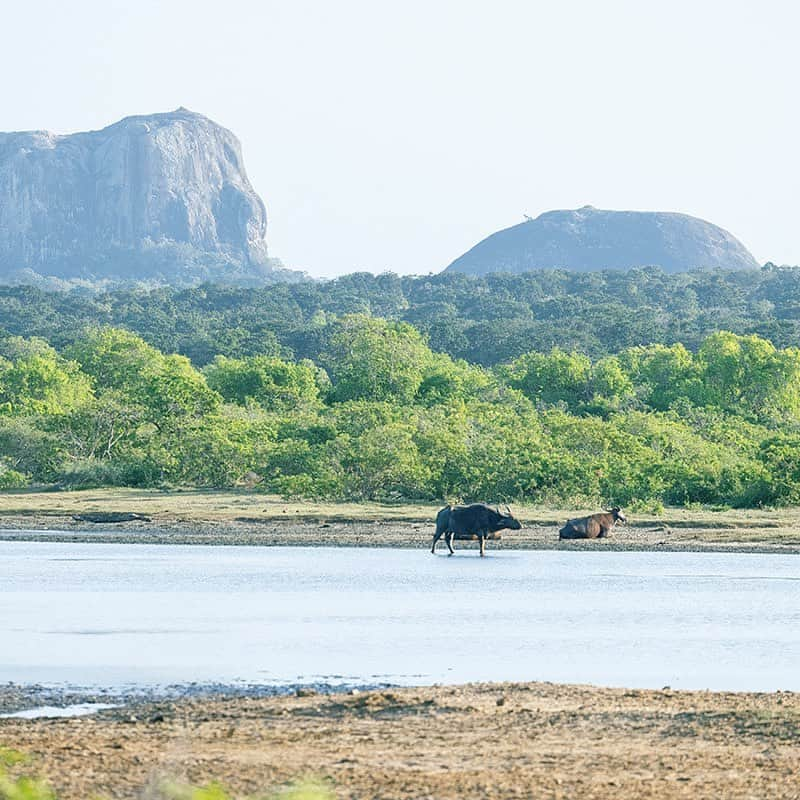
[0,489,800,553]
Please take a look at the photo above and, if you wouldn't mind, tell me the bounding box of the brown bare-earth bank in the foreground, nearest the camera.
[0,683,800,800]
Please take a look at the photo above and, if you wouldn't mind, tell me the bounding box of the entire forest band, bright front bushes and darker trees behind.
[0,269,800,508]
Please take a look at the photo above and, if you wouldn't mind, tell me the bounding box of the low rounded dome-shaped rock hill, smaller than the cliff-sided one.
[445,206,759,275]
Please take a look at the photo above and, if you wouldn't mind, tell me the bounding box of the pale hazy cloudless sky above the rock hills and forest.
[0,0,800,276]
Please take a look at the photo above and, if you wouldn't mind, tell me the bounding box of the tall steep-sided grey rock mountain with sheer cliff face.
[0,108,299,285]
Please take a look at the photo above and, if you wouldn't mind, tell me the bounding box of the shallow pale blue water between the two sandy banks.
[0,542,800,691]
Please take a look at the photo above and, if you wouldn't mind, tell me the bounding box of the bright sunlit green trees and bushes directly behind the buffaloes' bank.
[0,316,800,508]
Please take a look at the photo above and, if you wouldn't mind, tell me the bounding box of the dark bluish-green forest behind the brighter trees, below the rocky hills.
[0,265,800,367]
